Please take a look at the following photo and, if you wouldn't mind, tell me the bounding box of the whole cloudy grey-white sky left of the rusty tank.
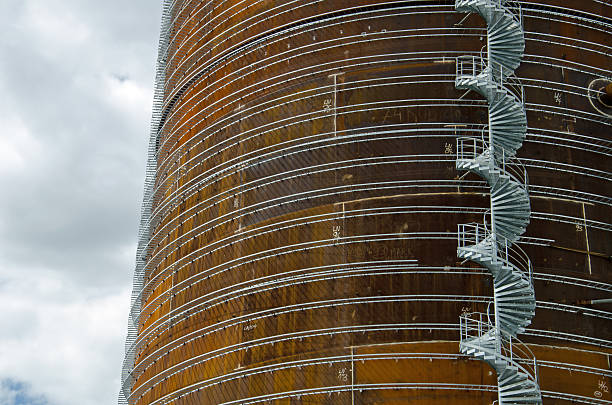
[0,0,162,405]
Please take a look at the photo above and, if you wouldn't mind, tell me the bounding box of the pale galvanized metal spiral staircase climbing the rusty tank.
[455,0,542,405]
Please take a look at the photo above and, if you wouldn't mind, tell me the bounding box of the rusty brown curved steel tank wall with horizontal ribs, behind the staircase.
[120,0,612,404]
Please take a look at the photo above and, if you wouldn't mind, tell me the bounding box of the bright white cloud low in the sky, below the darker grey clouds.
[0,270,129,405]
